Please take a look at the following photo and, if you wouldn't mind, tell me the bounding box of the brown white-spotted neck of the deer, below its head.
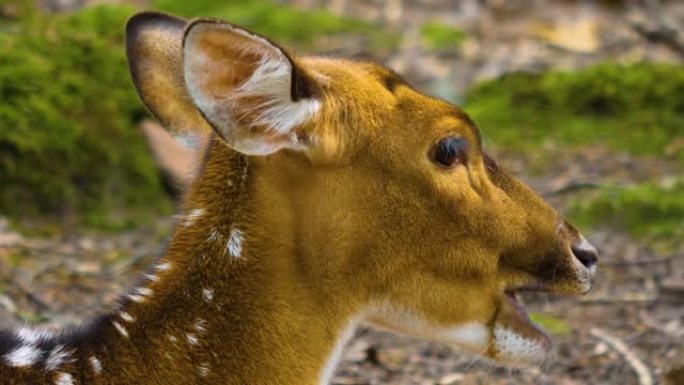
[102,142,359,385]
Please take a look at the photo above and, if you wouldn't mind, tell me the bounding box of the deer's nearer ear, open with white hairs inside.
[183,19,320,155]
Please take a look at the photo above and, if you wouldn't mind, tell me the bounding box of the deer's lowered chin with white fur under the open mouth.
[490,290,553,365]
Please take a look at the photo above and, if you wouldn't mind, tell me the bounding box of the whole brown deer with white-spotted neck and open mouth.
[0,11,598,385]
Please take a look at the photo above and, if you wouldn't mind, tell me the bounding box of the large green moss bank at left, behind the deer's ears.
[0,6,170,228]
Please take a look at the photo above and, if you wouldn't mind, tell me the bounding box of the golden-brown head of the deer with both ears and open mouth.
[129,14,597,366]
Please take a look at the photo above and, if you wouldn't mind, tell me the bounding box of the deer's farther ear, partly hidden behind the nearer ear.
[126,12,211,132]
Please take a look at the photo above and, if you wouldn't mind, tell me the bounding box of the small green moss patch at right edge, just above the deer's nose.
[570,180,684,242]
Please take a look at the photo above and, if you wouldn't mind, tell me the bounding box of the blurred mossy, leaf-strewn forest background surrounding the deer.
[0,0,684,385]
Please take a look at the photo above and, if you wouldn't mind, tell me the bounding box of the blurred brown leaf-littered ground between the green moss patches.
[0,0,684,385]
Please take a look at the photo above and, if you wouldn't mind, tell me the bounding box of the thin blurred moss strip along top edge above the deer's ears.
[152,0,398,47]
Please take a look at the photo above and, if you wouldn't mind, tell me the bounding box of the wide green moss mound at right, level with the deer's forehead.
[465,63,684,161]
